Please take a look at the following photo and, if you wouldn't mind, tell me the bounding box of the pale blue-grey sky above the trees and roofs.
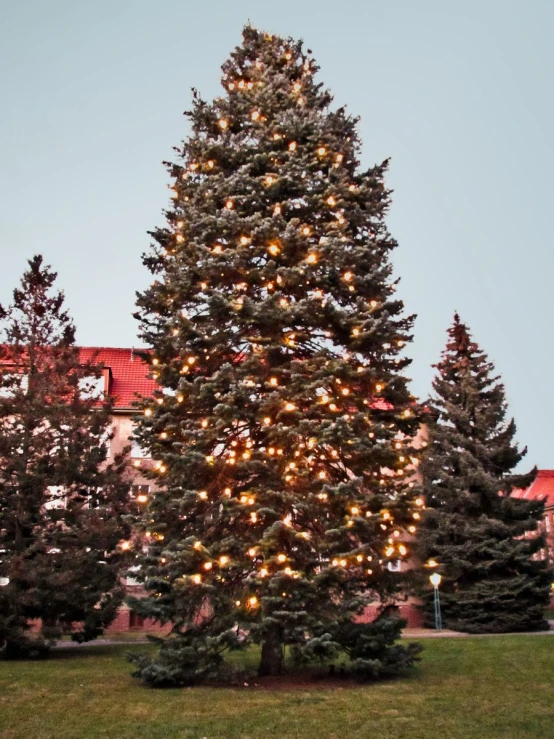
[0,0,554,468]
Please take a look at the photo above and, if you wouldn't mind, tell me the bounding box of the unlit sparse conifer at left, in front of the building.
[0,256,129,657]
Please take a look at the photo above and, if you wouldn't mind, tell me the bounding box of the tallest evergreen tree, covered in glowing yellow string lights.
[133,27,418,684]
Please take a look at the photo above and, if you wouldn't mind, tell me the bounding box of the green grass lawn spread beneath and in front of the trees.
[0,636,554,739]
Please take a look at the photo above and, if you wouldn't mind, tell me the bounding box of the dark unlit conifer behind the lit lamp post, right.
[418,314,550,633]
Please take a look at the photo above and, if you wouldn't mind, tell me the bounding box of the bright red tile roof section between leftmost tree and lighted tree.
[79,346,156,410]
